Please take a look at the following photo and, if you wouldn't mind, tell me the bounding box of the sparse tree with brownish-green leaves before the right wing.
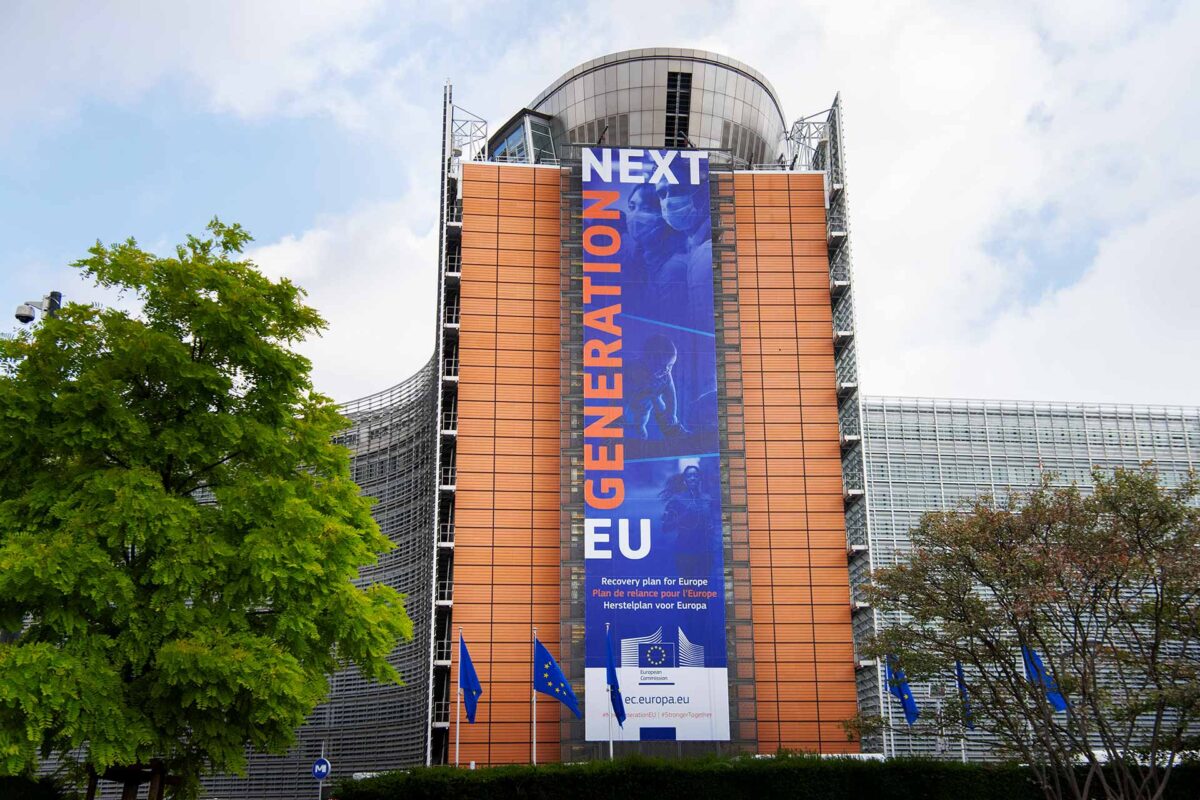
[870,467,1200,800]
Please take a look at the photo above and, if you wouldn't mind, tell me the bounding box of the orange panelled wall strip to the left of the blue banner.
[450,163,560,765]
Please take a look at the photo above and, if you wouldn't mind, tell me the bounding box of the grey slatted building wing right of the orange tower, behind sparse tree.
[856,397,1200,760]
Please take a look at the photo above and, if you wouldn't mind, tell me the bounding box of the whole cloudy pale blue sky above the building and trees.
[0,0,1200,405]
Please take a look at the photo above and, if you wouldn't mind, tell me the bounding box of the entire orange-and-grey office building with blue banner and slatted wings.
[209,48,1200,798]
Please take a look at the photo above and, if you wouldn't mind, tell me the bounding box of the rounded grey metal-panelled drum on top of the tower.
[529,47,787,164]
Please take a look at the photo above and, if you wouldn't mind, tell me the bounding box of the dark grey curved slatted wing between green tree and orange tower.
[206,361,438,798]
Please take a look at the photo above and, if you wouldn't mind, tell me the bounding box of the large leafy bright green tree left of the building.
[0,219,412,796]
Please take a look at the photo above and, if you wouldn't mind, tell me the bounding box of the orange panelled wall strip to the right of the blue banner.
[734,173,857,752]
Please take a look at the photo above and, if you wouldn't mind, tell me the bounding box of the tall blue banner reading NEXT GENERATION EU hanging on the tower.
[583,148,730,741]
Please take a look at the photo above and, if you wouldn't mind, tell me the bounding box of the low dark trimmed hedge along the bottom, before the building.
[334,756,1200,800]
